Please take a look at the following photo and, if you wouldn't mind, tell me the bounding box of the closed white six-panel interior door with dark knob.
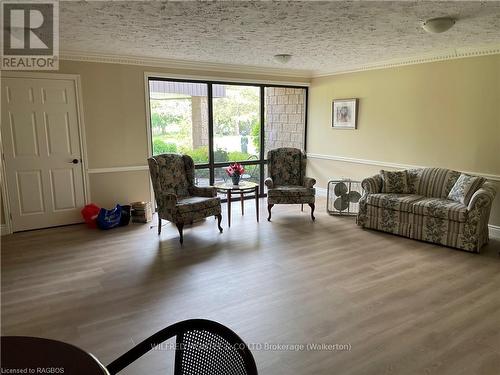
[1,77,85,231]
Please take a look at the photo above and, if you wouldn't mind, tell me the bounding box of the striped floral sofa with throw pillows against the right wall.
[357,168,496,252]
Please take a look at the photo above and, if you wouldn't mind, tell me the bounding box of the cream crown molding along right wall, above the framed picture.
[311,44,500,78]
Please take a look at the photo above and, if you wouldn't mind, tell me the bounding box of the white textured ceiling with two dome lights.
[60,1,500,73]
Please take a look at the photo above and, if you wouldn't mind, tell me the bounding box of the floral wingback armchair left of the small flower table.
[148,154,222,243]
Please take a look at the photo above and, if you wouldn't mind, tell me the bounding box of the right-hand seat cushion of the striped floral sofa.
[412,198,467,222]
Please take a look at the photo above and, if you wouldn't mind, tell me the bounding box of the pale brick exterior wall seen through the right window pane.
[264,87,305,153]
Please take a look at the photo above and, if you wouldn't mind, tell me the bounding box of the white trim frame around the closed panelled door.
[0,71,90,235]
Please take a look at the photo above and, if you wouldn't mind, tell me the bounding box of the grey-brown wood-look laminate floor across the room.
[1,199,500,375]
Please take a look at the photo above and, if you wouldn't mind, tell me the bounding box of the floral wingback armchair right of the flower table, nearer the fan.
[265,147,316,221]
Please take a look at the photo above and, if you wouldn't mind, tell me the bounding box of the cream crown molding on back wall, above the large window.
[59,50,312,80]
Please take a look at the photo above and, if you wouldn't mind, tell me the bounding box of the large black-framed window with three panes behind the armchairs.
[149,78,307,194]
